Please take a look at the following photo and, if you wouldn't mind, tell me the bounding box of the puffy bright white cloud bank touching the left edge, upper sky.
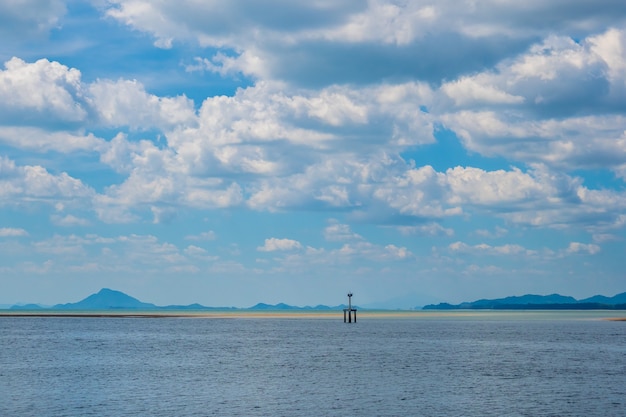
[0,57,196,136]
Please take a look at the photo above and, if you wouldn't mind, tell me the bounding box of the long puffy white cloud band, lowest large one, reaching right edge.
[239,148,626,233]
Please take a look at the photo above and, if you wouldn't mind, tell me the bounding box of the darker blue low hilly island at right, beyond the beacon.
[423,292,626,310]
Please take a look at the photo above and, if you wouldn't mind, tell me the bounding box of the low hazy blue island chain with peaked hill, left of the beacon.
[10,288,345,311]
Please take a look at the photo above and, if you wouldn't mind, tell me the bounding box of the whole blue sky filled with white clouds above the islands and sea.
[0,0,626,308]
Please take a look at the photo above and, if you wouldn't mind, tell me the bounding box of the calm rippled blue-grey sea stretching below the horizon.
[0,312,626,417]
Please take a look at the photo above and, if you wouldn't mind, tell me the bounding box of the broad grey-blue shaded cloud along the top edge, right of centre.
[102,0,624,87]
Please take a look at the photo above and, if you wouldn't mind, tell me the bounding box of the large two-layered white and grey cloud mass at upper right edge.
[441,29,626,173]
